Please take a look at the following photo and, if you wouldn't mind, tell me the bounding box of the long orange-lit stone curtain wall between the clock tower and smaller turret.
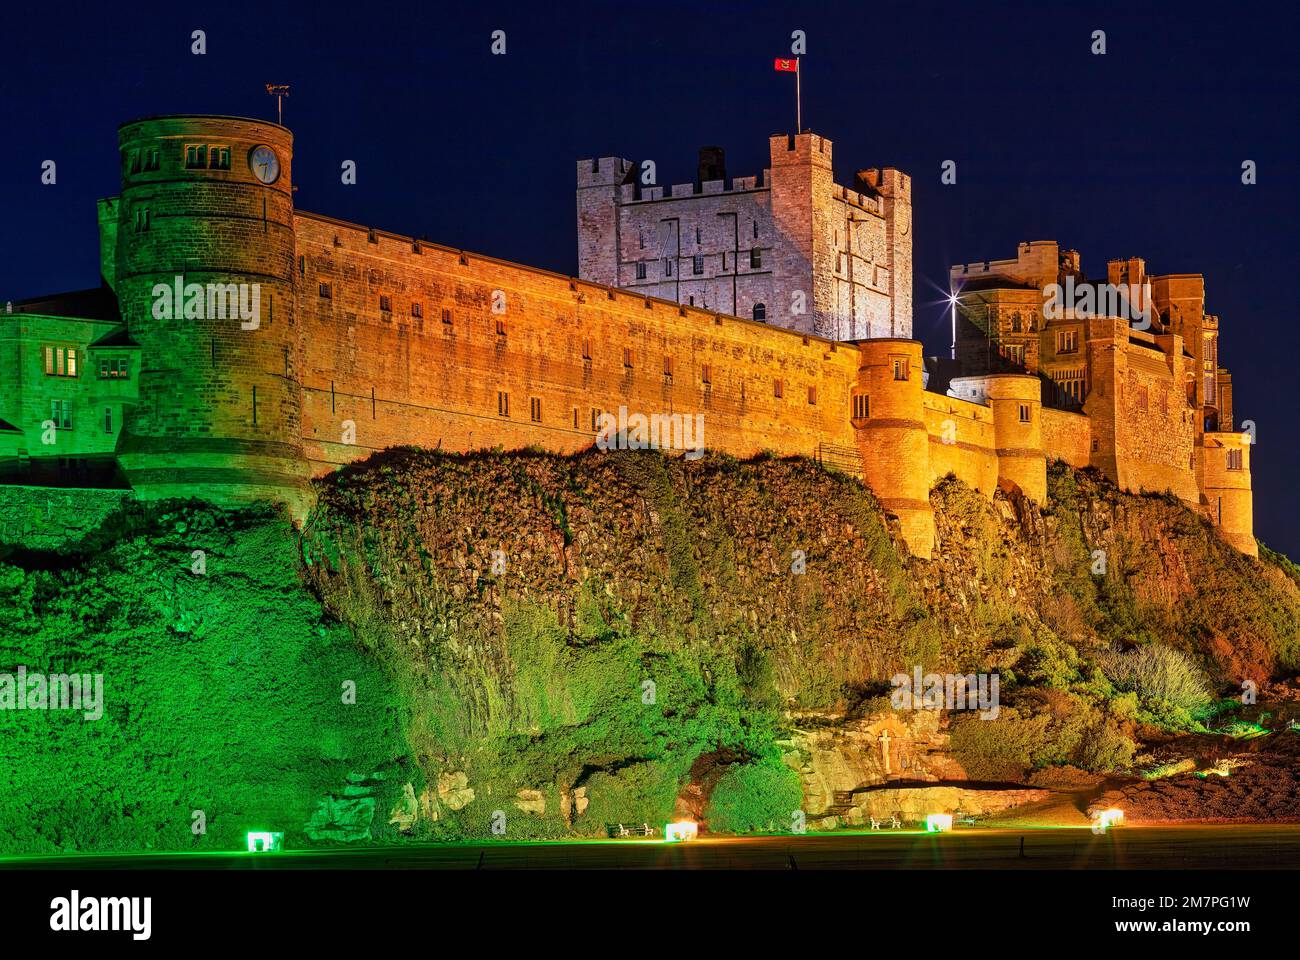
[296,213,858,472]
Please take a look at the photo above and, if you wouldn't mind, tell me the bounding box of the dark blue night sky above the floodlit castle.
[0,0,1300,557]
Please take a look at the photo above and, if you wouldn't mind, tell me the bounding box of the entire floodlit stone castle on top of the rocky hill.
[0,116,1256,558]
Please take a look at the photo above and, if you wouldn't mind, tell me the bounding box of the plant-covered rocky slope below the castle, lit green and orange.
[0,450,1300,852]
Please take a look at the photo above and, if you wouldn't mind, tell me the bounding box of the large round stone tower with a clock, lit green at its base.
[116,116,308,514]
